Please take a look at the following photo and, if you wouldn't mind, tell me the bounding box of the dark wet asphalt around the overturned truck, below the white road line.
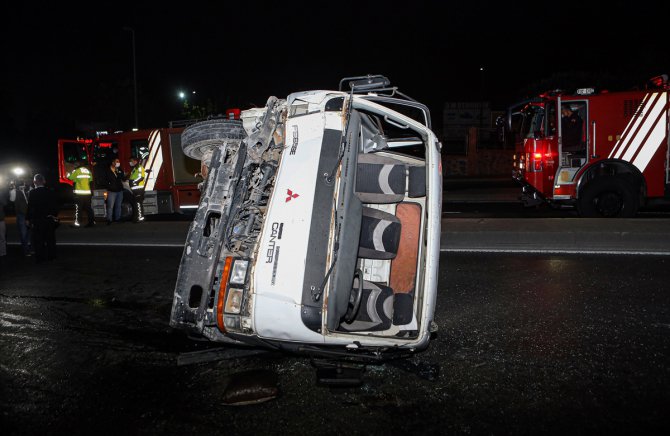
[0,247,670,435]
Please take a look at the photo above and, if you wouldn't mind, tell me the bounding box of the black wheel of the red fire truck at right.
[577,177,639,218]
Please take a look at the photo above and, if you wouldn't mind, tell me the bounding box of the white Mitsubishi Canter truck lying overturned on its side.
[170,76,442,361]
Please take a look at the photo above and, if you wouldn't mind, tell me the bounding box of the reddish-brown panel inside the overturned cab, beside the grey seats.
[390,203,421,294]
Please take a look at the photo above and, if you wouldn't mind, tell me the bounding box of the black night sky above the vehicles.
[0,0,670,174]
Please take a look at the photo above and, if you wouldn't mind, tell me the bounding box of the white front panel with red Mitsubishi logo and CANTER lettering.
[253,112,325,340]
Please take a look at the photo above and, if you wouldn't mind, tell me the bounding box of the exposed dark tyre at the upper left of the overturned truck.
[181,119,247,160]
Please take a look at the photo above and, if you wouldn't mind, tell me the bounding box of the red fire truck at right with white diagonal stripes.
[506,75,670,217]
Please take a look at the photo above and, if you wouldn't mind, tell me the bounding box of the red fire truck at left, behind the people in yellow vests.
[58,127,202,219]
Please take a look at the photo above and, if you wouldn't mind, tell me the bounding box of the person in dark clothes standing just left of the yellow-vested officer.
[26,174,58,263]
